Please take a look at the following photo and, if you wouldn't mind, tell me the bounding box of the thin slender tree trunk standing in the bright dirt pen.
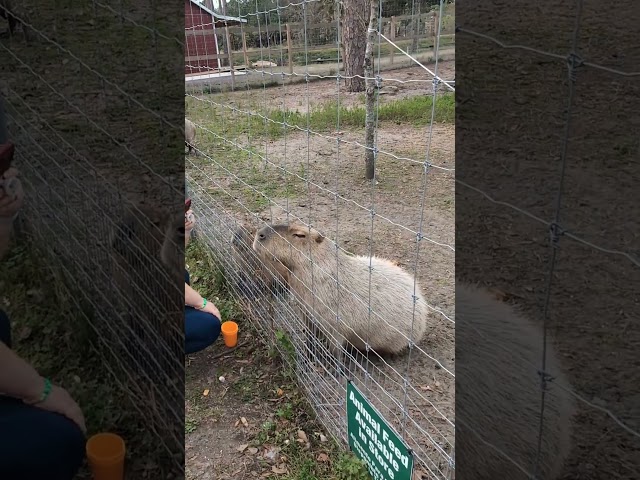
[364,0,378,181]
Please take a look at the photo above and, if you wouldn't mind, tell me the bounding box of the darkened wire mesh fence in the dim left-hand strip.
[0,1,184,469]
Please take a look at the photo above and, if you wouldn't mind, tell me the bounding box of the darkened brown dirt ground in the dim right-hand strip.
[456,1,640,480]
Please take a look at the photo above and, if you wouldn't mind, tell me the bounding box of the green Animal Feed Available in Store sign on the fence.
[347,382,413,480]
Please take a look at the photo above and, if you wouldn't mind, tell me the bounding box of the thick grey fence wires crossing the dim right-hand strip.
[456,0,640,479]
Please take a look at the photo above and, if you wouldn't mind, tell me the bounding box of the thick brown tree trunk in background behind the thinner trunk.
[342,0,371,92]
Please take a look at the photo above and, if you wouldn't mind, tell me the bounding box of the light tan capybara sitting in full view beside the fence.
[253,224,429,354]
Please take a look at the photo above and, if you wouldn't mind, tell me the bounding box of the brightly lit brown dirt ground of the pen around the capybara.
[187,62,455,478]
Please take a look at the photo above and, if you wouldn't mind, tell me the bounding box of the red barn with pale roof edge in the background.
[184,0,247,74]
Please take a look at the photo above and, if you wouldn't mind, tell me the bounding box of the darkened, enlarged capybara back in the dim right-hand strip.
[456,283,574,480]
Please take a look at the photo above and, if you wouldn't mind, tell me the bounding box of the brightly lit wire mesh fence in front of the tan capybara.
[185,1,455,478]
